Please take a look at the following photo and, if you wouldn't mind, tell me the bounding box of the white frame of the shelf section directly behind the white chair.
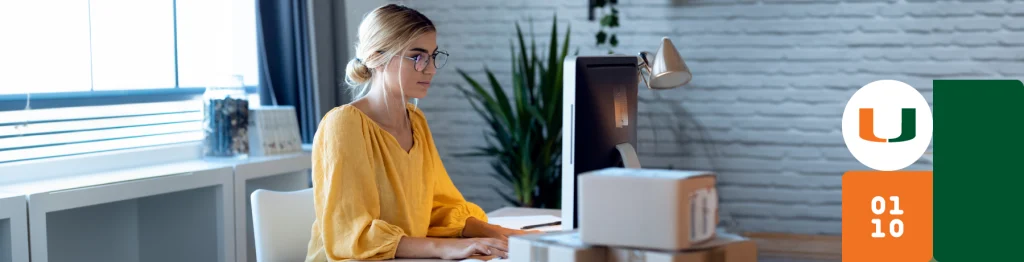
[233,151,312,262]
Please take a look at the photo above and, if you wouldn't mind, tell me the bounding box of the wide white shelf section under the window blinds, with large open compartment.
[0,160,234,262]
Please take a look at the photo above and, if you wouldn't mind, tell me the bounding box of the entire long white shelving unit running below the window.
[0,147,311,262]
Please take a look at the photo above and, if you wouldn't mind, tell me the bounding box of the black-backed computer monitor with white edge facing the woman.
[561,55,640,230]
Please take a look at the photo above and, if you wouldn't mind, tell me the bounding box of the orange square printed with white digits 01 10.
[843,171,932,262]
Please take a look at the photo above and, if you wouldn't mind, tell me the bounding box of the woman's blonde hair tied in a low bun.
[345,4,436,98]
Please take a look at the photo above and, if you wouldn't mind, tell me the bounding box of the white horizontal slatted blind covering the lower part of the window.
[0,100,203,164]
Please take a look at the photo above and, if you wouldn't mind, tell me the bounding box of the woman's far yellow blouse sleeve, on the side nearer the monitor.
[426,112,487,237]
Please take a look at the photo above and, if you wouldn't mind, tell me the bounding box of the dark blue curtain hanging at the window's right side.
[256,0,319,143]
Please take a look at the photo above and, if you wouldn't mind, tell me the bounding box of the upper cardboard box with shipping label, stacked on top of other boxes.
[578,168,718,251]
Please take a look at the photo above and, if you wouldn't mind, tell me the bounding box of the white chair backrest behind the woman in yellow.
[250,188,316,262]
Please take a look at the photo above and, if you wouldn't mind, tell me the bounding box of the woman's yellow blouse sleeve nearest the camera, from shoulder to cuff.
[312,108,406,261]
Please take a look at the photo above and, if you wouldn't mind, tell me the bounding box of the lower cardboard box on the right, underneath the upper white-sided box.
[607,232,758,262]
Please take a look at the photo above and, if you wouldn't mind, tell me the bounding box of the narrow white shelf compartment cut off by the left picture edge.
[0,191,29,262]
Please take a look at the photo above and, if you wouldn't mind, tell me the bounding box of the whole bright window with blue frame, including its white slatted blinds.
[0,0,259,164]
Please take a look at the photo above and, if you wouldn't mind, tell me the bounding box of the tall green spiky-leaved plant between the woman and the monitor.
[457,16,569,208]
